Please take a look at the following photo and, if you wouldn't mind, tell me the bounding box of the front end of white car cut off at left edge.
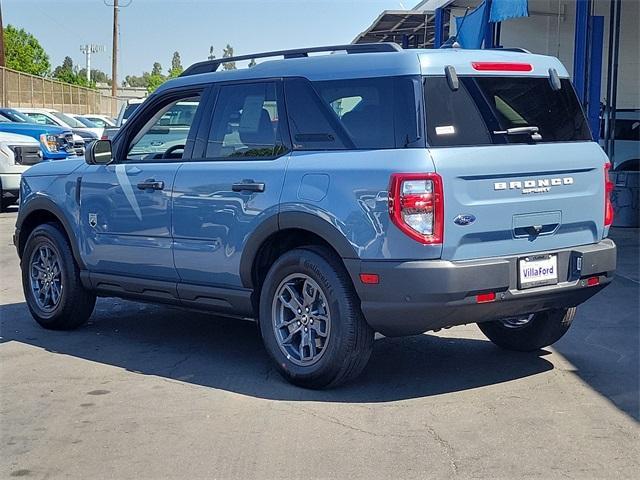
[0,132,42,212]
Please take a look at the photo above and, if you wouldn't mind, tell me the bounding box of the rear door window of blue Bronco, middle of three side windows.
[206,82,286,159]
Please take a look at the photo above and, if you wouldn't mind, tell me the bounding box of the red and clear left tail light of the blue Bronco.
[389,173,444,244]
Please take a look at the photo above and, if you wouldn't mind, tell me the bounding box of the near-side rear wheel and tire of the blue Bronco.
[260,247,374,389]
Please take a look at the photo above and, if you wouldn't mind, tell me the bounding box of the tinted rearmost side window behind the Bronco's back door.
[286,77,424,150]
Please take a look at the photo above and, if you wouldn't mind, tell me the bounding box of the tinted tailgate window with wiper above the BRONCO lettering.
[424,76,591,147]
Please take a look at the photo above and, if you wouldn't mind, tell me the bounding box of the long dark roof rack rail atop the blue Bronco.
[180,42,402,77]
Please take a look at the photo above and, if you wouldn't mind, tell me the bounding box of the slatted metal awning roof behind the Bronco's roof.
[352,10,448,48]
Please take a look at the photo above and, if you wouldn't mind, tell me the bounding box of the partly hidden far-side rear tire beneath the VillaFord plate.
[478,307,576,352]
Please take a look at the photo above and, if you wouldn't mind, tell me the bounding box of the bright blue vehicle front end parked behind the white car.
[0,108,77,160]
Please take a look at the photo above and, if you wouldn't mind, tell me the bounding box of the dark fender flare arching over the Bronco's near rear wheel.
[240,212,358,288]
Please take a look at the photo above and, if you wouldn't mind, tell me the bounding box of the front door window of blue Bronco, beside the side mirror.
[127,95,200,161]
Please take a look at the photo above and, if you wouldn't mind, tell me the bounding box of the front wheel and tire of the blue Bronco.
[21,223,96,330]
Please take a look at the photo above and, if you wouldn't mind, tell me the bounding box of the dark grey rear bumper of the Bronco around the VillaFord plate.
[345,239,616,336]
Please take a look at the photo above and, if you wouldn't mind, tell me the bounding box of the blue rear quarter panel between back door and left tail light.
[280,149,441,260]
